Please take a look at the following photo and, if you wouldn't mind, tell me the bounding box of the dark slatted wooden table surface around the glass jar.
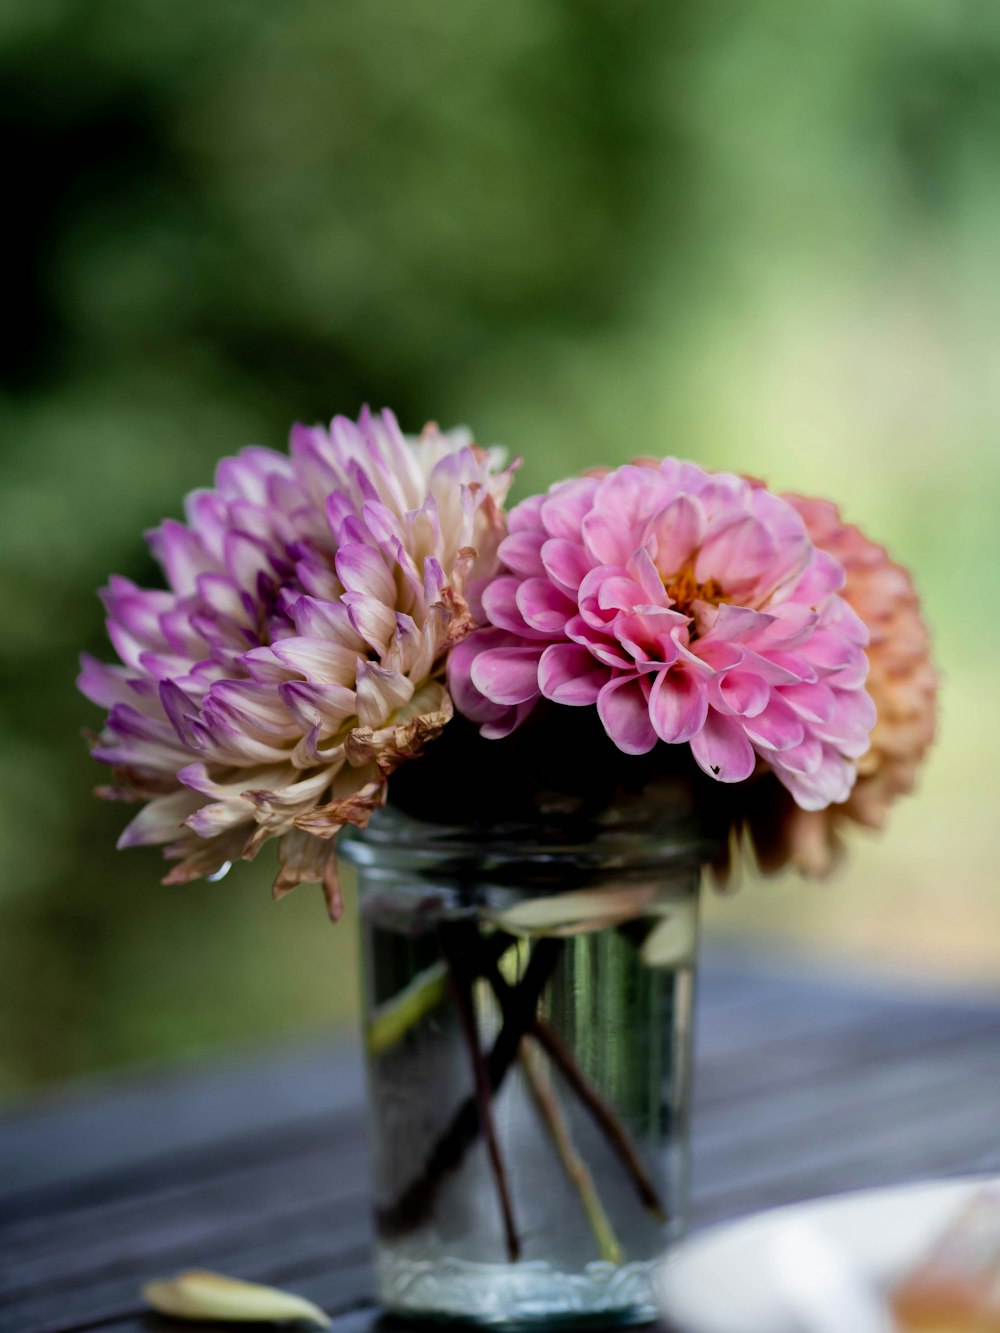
[0,952,1000,1333]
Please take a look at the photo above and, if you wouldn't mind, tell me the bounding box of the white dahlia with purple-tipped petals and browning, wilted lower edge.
[79,411,511,914]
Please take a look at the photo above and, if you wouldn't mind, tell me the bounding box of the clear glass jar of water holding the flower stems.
[344,802,704,1325]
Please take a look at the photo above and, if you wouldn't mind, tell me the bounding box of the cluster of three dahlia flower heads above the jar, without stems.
[79,412,936,895]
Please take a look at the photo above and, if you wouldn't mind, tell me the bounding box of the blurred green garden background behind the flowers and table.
[0,0,1000,1096]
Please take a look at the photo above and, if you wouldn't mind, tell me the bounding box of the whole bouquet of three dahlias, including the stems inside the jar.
[80,412,936,1322]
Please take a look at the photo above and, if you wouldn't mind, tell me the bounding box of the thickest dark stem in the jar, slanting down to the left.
[376,938,563,1237]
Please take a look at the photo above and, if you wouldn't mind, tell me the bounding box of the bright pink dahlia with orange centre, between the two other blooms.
[448,459,875,809]
